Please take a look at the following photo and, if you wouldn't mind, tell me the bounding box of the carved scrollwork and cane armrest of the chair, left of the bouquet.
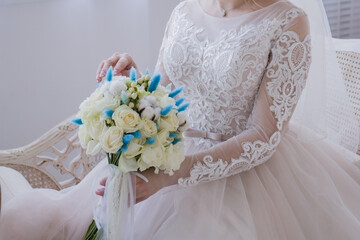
[0,118,105,190]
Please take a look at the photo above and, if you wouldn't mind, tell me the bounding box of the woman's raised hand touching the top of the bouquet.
[96,52,139,82]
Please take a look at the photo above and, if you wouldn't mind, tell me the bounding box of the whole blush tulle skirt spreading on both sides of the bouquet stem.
[0,123,360,240]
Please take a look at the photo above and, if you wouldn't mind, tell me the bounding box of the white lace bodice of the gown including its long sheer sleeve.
[158,0,310,184]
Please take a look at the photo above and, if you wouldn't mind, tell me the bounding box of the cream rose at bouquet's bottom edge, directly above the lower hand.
[141,142,166,168]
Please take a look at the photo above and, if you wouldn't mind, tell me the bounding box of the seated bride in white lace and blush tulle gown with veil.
[0,0,360,240]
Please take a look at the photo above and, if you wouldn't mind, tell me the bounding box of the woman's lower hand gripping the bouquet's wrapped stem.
[95,169,178,203]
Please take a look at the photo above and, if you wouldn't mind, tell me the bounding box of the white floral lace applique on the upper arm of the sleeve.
[266,31,311,130]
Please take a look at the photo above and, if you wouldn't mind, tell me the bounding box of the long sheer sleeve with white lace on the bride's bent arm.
[178,15,311,186]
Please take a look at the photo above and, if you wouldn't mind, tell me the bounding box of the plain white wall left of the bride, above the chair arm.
[0,0,179,149]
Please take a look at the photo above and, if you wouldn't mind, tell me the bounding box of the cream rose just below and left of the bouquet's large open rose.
[101,126,124,153]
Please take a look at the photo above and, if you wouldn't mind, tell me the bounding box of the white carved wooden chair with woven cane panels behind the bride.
[0,40,360,190]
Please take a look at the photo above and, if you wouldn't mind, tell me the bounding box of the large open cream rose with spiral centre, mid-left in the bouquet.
[112,105,141,132]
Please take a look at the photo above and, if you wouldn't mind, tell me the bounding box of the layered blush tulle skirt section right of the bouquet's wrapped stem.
[135,126,360,240]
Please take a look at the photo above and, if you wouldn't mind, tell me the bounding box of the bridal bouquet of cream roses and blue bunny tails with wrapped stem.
[73,68,189,239]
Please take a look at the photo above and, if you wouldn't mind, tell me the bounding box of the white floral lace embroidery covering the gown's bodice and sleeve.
[162,2,310,185]
